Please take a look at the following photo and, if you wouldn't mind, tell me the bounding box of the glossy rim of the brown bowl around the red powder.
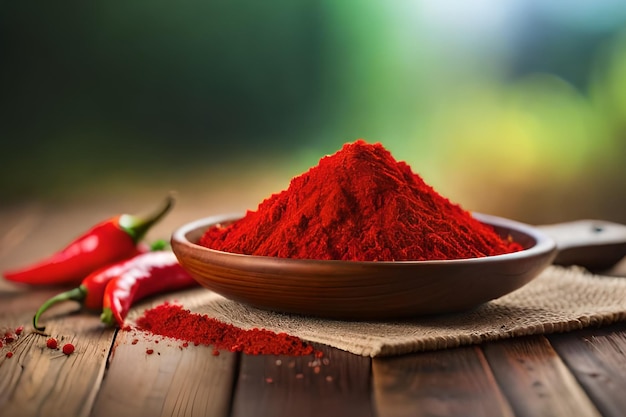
[171,212,557,267]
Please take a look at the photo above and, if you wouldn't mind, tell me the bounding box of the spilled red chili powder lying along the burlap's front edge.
[136,303,315,356]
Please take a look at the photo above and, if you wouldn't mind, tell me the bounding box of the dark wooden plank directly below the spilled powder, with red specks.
[232,347,373,417]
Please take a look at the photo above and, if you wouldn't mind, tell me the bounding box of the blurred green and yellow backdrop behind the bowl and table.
[0,0,626,223]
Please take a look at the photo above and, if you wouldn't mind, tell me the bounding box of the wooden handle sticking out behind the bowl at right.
[536,220,626,271]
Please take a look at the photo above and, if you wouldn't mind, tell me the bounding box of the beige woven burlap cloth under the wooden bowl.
[157,266,626,357]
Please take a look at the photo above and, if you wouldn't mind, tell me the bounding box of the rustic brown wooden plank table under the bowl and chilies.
[0,200,626,417]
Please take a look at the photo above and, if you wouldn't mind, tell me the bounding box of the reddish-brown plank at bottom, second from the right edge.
[483,336,599,417]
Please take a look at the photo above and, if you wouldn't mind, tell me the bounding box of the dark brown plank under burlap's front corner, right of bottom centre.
[372,347,513,417]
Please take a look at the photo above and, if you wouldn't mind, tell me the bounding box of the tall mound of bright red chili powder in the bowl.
[199,139,522,261]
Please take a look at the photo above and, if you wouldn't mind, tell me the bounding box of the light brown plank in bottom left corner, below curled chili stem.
[0,315,113,417]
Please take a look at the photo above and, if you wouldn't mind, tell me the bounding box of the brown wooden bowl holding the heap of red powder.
[171,213,556,320]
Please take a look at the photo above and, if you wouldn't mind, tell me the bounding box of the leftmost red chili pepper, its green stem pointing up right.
[3,195,174,285]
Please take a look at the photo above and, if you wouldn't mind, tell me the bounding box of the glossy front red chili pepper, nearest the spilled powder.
[100,251,197,327]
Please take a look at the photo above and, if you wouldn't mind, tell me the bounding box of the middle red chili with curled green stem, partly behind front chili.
[33,240,166,332]
